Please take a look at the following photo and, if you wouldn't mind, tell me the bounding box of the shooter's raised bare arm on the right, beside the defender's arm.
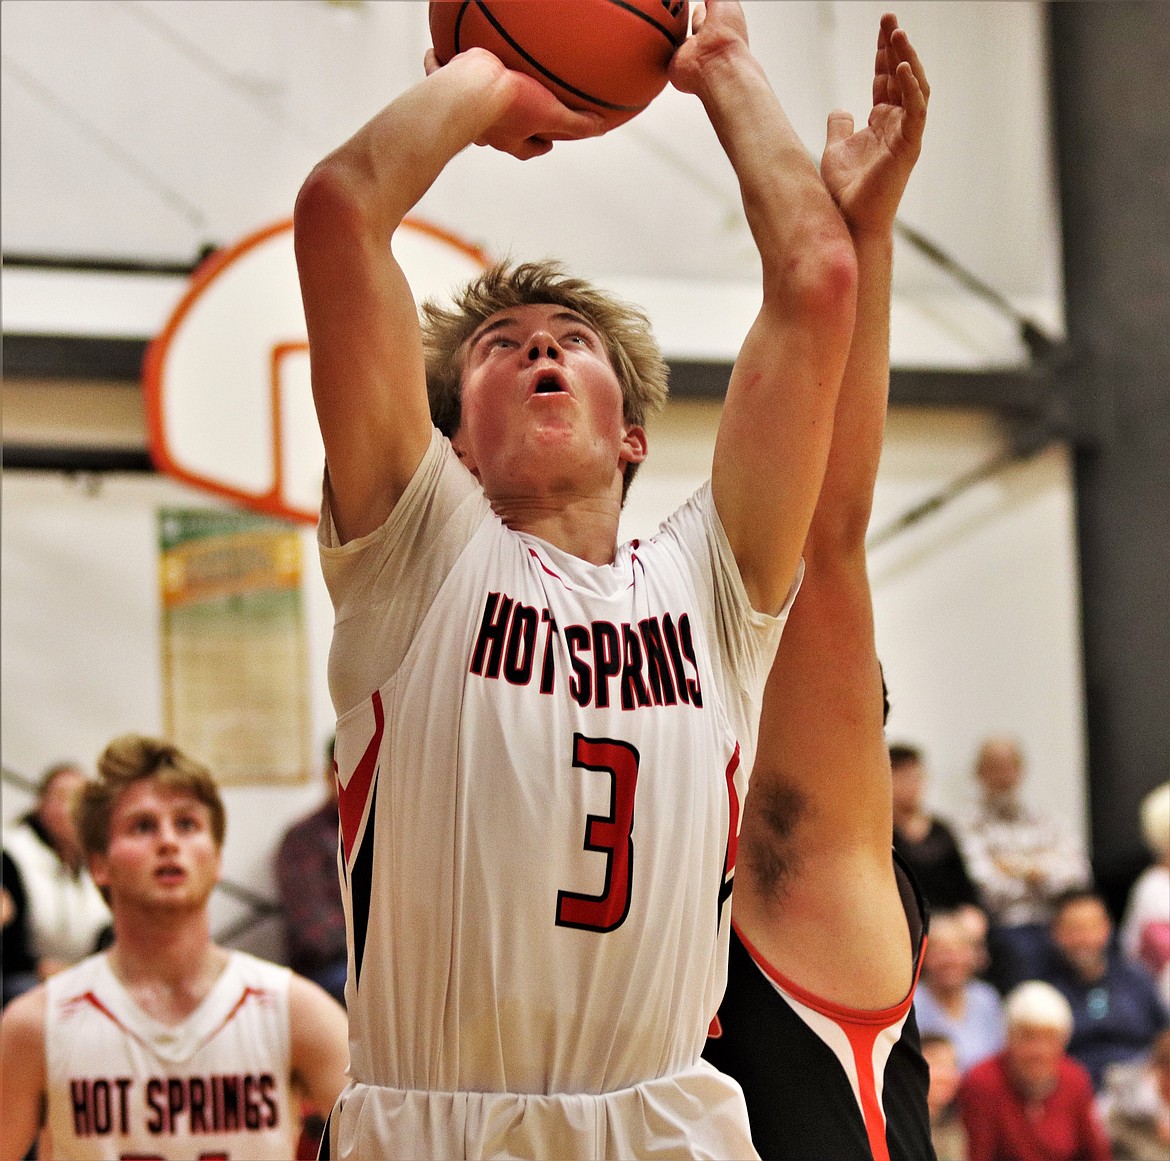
[670,0,856,612]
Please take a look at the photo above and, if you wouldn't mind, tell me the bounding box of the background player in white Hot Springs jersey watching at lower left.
[0,735,347,1161]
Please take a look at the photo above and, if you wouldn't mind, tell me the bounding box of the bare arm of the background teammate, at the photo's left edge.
[0,987,46,1161]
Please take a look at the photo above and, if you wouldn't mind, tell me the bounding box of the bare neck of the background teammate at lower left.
[109,912,229,1024]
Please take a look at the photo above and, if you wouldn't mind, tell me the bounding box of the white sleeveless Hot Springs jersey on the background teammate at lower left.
[44,952,300,1161]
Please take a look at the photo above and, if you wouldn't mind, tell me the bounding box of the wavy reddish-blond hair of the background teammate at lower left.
[74,734,227,856]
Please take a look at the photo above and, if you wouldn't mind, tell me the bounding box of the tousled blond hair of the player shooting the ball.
[420,260,668,499]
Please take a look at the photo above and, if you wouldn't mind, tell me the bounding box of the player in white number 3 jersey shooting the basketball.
[295,0,856,1159]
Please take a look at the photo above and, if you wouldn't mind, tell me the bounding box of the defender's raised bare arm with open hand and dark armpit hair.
[734,15,929,1009]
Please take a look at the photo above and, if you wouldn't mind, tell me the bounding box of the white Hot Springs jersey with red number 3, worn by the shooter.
[322,435,787,1155]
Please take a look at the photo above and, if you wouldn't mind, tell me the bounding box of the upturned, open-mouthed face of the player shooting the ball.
[453,305,646,499]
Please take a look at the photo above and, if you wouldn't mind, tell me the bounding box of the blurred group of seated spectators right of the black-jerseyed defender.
[890,737,1170,1161]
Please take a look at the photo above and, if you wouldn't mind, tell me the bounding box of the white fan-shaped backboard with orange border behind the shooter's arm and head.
[143,219,487,523]
